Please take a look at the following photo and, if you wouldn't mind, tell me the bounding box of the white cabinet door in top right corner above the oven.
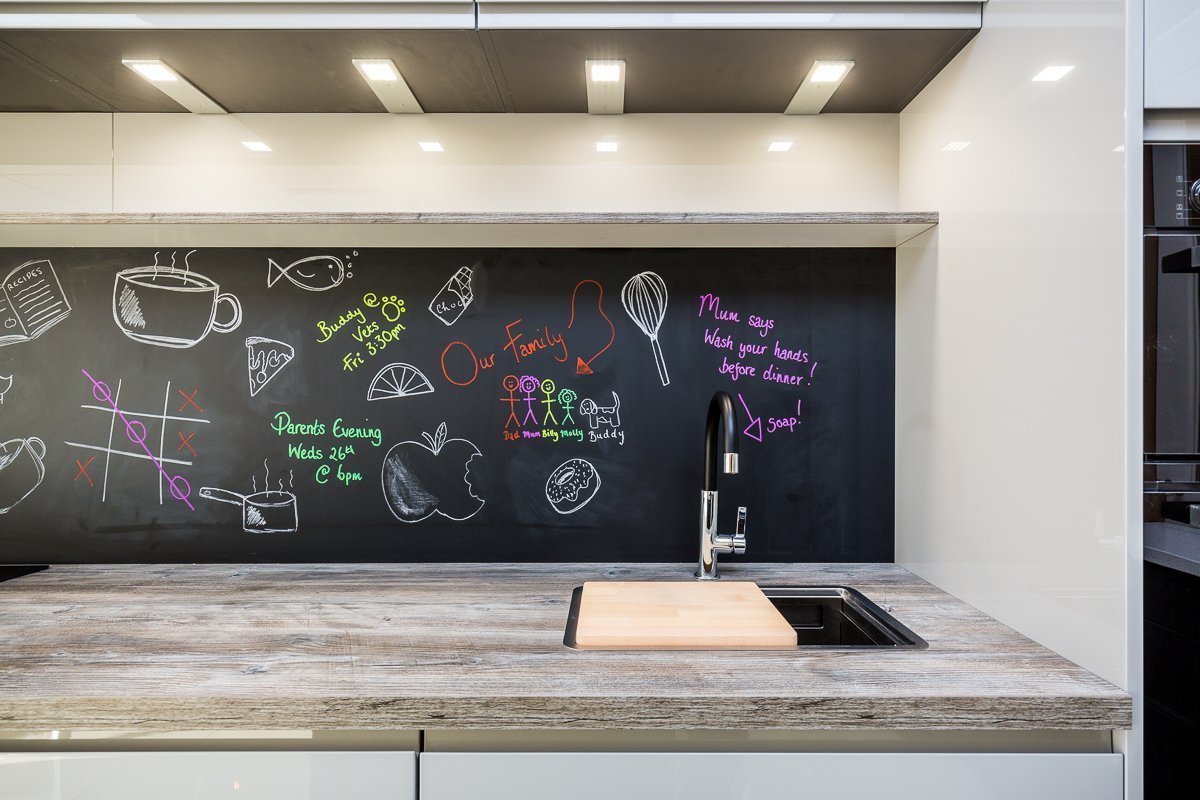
[1145,0,1200,108]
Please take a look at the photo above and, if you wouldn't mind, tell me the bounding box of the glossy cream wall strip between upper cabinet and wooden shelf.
[0,114,898,212]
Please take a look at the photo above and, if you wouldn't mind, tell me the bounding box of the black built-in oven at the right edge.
[1144,143,1200,525]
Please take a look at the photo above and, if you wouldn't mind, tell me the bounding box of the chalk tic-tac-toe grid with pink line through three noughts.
[65,369,209,510]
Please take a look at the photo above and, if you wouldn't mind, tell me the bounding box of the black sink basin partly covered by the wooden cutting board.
[563,587,929,650]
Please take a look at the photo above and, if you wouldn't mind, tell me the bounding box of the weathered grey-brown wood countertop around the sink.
[0,564,1132,730]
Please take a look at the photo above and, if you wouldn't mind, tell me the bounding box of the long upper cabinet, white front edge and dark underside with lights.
[0,0,983,114]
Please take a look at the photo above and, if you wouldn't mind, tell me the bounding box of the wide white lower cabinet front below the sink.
[420,753,1123,800]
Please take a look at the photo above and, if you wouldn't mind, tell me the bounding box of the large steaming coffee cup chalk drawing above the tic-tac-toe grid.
[113,266,241,348]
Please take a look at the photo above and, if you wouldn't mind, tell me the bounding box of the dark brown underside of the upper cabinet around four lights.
[0,29,976,114]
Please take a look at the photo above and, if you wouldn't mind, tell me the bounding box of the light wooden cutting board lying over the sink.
[575,581,796,650]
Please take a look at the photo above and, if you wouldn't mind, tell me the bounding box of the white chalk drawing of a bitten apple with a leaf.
[380,422,484,522]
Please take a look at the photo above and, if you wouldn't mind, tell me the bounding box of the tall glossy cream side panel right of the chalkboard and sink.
[896,0,1140,685]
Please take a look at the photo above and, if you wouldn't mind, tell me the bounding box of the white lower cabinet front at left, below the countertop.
[0,752,416,800]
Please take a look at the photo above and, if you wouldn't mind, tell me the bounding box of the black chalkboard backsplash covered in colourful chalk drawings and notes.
[0,248,895,563]
